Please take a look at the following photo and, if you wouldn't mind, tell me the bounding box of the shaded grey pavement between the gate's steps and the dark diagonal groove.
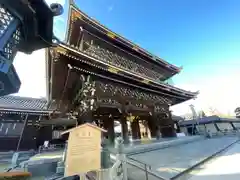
[127,137,237,180]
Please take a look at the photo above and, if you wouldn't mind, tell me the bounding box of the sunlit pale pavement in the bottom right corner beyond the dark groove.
[189,143,240,180]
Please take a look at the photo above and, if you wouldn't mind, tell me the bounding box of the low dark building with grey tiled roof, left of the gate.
[0,95,57,151]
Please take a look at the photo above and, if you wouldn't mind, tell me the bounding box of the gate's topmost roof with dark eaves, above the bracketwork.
[66,1,181,81]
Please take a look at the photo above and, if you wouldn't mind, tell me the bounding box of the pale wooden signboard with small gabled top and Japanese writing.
[62,123,105,176]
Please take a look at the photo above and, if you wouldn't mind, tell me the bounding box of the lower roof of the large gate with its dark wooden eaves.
[47,45,197,113]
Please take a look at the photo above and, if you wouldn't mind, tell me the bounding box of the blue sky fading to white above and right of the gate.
[13,0,240,113]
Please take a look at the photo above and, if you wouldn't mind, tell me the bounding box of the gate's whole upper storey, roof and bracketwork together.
[66,1,180,82]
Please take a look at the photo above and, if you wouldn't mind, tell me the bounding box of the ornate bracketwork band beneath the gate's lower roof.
[97,81,172,104]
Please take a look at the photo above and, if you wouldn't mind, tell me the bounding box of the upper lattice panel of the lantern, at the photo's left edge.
[0,5,14,37]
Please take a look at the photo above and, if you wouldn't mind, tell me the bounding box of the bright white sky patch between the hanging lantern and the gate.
[13,49,46,97]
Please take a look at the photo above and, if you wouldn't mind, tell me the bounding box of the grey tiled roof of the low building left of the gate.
[0,95,48,111]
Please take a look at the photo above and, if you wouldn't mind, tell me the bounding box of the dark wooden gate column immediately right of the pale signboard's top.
[102,116,115,143]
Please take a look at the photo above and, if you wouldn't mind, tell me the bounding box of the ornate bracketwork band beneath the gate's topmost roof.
[84,41,162,80]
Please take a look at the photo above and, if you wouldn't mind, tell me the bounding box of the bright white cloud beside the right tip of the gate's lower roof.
[172,72,240,115]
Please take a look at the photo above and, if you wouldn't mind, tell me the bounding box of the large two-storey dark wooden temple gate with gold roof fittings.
[46,1,198,142]
